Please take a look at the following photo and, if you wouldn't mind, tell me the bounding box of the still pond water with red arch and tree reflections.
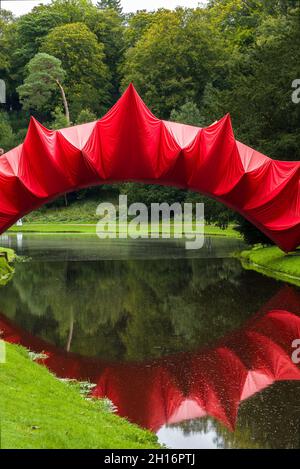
[0,234,300,448]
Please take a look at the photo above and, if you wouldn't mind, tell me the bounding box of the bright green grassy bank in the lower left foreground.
[0,344,159,449]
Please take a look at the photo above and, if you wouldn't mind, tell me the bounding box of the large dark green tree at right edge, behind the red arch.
[201,0,300,160]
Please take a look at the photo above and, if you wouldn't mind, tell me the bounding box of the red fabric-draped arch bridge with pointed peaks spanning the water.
[0,85,300,251]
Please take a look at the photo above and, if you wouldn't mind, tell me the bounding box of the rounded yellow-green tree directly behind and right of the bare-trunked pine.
[42,23,110,115]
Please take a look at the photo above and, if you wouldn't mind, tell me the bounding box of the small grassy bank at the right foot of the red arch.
[238,246,300,286]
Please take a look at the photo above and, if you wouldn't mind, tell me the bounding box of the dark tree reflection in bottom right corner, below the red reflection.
[169,381,300,449]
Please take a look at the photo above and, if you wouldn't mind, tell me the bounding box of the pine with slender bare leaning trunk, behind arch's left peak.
[17,53,70,125]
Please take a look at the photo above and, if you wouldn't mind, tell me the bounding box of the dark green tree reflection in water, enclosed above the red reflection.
[0,259,278,360]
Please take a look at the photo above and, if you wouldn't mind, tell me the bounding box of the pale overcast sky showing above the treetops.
[0,0,206,15]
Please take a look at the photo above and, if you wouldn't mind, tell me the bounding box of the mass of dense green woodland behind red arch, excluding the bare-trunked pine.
[0,0,300,241]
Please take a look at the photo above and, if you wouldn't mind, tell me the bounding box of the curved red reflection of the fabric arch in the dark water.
[0,288,300,430]
